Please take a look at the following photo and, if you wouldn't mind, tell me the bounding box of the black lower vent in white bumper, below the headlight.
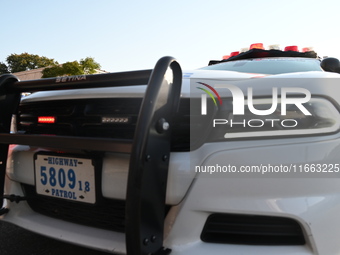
[201,214,305,245]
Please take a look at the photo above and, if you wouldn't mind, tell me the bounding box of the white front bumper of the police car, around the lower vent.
[2,135,340,254]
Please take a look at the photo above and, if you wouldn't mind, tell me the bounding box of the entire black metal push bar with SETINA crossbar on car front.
[0,57,182,255]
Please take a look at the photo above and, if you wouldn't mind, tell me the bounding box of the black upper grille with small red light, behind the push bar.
[17,98,190,151]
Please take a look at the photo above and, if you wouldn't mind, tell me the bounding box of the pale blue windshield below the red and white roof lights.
[201,58,322,74]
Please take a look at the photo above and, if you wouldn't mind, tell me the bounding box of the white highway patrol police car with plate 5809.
[0,43,340,255]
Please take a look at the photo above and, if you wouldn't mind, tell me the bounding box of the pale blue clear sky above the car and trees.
[0,0,340,72]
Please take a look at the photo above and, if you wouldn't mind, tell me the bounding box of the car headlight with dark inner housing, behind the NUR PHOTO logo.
[191,98,340,144]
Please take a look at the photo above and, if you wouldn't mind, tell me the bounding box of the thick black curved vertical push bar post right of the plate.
[126,57,182,255]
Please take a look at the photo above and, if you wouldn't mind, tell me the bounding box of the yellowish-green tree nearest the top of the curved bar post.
[42,57,100,78]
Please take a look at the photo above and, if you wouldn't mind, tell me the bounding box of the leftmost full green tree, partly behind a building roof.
[6,52,58,73]
